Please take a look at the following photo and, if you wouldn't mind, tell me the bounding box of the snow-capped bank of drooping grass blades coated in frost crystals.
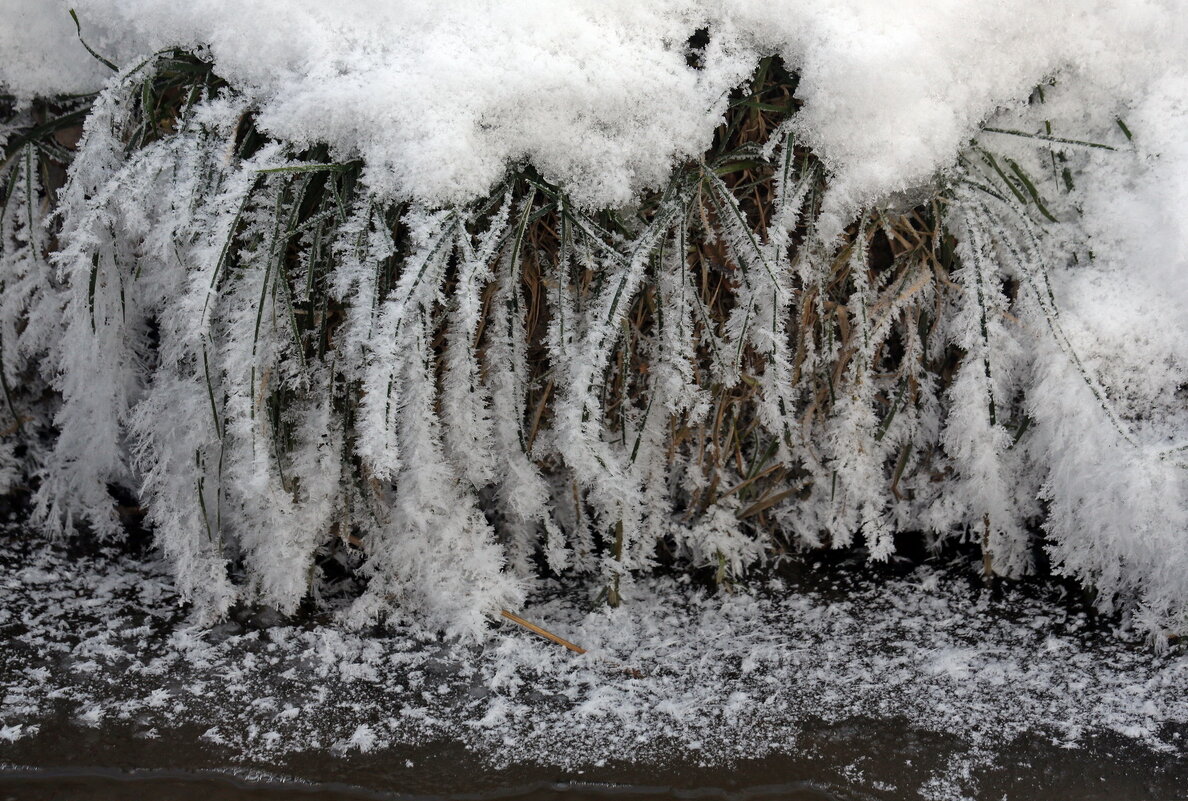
[0,0,1188,641]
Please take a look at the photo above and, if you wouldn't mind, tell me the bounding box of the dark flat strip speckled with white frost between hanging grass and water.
[0,518,1188,797]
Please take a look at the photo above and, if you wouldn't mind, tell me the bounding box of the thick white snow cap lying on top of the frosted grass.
[0,0,1186,209]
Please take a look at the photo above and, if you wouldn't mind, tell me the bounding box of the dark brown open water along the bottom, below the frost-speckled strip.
[0,719,1188,801]
